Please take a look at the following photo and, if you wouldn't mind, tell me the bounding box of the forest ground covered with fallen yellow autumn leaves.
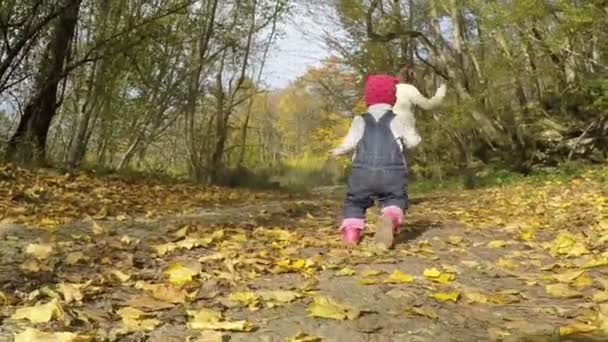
[0,166,608,342]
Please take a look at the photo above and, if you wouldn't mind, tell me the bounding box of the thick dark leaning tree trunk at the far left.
[6,0,81,163]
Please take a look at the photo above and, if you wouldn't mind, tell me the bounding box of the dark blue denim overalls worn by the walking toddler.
[342,111,408,219]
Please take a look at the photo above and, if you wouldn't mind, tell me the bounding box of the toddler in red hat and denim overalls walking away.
[331,75,446,248]
